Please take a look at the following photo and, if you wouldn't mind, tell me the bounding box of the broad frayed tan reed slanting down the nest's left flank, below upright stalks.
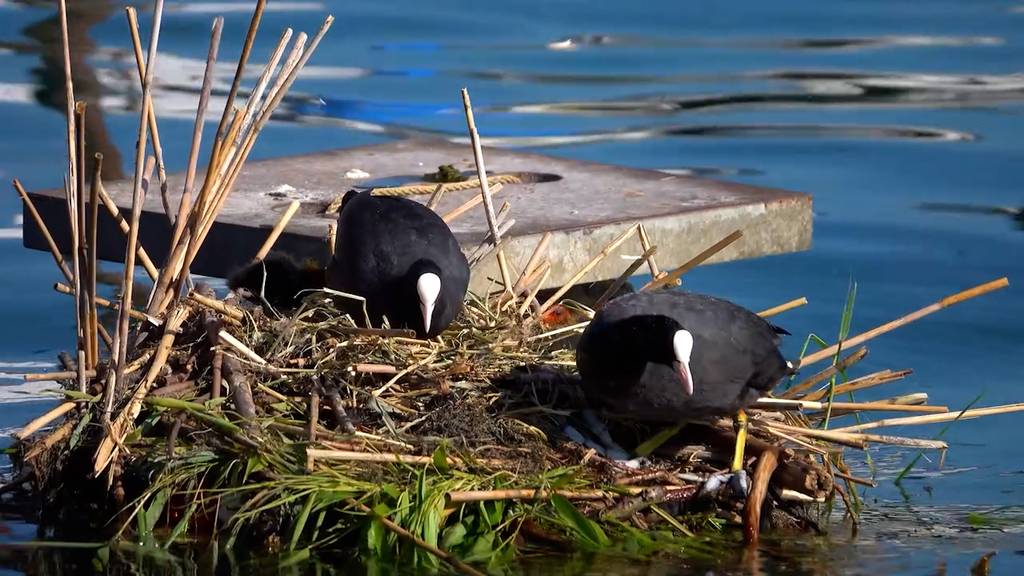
[93,303,191,477]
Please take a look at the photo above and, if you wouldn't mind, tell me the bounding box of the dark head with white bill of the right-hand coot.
[616,315,693,395]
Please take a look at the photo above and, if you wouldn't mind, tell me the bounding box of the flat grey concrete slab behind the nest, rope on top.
[24,140,812,289]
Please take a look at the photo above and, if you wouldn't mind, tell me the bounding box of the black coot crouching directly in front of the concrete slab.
[327,191,469,337]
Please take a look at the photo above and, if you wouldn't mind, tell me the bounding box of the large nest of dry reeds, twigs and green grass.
[3,0,1024,574]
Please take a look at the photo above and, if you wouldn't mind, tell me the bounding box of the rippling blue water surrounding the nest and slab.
[0,0,1024,574]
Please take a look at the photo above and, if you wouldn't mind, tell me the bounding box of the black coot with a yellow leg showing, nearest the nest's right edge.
[577,291,791,422]
